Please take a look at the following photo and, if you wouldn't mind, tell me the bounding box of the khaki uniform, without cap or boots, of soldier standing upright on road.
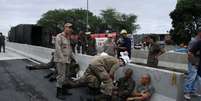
[54,32,72,87]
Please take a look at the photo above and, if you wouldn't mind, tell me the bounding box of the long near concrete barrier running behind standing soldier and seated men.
[7,43,187,101]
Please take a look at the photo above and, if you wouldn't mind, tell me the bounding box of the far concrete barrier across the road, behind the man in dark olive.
[132,50,188,71]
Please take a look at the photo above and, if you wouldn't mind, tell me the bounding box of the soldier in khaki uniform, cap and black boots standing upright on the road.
[54,23,73,100]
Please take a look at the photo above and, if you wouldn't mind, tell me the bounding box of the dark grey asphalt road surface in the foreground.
[0,50,201,101]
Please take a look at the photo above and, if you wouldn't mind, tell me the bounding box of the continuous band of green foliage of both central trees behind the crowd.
[37,9,139,33]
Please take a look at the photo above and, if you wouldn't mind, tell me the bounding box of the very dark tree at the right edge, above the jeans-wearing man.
[170,0,201,44]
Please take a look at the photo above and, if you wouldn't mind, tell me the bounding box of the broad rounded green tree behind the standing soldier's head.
[37,9,100,33]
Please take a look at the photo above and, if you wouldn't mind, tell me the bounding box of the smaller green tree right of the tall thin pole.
[101,9,139,33]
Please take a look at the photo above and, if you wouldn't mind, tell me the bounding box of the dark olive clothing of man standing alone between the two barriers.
[147,43,162,67]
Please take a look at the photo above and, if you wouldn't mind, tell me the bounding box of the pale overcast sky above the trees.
[0,0,177,35]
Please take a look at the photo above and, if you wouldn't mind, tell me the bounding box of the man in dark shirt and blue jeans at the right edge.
[184,29,201,100]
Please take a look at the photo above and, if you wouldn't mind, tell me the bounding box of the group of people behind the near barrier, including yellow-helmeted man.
[71,29,131,57]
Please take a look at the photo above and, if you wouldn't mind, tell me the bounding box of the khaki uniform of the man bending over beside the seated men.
[77,56,119,96]
